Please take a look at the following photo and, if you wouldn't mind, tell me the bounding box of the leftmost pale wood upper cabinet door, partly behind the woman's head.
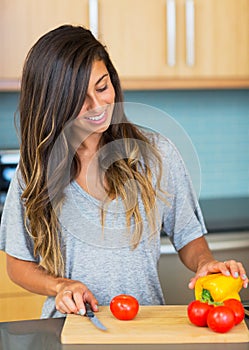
[0,0,88,79]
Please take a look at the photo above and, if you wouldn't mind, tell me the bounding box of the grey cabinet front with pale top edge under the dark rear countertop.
[159,230,249,304]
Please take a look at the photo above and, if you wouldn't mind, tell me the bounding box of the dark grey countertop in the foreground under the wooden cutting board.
[0,318,249,350]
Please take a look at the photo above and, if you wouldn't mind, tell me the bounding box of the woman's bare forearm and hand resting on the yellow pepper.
[179,236,248,289]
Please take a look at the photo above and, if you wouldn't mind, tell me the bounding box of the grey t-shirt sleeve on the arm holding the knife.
[0,169,37,262]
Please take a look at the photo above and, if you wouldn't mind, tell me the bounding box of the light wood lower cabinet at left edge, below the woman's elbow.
[0,252,46,322]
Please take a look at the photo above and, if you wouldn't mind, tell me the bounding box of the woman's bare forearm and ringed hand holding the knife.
[7,254,98,314]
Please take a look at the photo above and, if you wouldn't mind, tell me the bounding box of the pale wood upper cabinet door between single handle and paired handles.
[99,0,167,78]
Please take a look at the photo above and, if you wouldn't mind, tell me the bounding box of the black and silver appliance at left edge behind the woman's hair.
[0,150,20,214]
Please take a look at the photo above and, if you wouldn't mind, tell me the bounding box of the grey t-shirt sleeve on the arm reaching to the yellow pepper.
[159,138,207,251]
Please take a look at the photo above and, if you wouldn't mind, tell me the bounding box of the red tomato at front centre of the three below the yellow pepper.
[207,305,235,333]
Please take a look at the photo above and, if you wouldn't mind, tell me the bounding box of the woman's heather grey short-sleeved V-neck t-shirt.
[0,134,206,318]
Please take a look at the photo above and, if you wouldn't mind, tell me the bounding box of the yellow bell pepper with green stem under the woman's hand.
[195,273,243,303]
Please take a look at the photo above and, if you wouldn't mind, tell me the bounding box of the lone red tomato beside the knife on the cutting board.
[110,294,139,320]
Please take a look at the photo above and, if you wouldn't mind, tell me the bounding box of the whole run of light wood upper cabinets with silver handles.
[0,0,249,89]
